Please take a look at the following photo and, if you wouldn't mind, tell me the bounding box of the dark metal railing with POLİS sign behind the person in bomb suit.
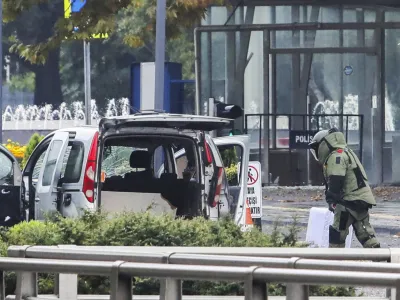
[244,114,364,186]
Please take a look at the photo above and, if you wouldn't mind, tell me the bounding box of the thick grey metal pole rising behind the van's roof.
[154,0,166,110]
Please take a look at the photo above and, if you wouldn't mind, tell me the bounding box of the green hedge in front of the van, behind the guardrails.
[0,213,354,296]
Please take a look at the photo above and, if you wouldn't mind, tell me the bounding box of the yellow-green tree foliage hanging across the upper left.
[3,0,224,64]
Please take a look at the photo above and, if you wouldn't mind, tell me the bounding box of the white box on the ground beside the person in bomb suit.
[306,207,353,248]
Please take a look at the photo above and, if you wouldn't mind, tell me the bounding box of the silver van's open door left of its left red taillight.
[35,131,69,220]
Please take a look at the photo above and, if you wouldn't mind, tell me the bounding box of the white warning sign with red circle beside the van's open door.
[246,161,262,219]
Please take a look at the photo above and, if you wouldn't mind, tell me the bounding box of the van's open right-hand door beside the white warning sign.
[213,135,250,227]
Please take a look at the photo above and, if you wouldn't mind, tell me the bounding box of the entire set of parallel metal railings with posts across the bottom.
[6,246,400,300]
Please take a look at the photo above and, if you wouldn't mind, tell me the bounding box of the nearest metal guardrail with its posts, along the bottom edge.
[5,254,400,300]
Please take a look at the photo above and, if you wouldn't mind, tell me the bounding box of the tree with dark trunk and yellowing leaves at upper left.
[3,0,223,105]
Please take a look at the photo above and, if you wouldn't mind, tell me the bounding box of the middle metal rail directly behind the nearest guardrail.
[8,246,400,273]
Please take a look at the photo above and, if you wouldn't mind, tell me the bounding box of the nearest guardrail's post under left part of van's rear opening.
[110,261,132,300]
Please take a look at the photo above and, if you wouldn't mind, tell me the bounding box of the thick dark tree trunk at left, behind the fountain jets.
[34,48,63,109]
